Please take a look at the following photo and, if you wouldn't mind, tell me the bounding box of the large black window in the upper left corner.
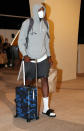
[0,0,30,29]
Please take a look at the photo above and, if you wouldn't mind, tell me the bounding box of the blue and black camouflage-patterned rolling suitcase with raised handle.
[15,60,39,122]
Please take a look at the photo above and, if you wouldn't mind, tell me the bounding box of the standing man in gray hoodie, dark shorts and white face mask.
[18,5,56,117]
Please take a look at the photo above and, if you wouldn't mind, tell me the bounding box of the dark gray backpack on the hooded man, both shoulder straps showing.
[25,18,50,49]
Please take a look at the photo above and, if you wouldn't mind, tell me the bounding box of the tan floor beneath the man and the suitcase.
[0,70,84,131]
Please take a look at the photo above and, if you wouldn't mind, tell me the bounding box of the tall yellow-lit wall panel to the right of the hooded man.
[45,0,81,80]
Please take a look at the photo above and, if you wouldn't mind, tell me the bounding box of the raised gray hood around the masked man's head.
[33,4,46,21]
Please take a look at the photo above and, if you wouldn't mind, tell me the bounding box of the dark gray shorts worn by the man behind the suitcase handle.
[25,59,50,80]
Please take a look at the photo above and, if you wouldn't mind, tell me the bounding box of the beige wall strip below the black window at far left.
[0,29,18,43]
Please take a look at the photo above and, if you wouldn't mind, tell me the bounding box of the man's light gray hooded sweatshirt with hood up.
[18,5,50,59]
